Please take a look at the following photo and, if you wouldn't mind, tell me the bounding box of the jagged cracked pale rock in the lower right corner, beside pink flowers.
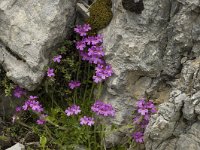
[145,57,200,150]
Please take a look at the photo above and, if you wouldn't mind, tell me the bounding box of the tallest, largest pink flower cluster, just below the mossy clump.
[74,24,113,83]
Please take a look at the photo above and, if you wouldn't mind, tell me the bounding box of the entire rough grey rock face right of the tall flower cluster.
[102,0,200,150]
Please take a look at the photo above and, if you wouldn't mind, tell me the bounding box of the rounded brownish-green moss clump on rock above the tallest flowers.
[86,0,113,32]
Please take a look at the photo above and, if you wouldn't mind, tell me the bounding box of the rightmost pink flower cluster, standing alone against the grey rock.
[133,99,157,143]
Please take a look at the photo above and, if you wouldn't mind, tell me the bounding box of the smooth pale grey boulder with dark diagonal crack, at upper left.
[0,0,76,90]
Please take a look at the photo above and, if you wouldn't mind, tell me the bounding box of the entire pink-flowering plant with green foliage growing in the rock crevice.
[1,24,156,150]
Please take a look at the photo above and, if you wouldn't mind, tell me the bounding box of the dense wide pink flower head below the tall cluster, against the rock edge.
[91,100,115,116]
